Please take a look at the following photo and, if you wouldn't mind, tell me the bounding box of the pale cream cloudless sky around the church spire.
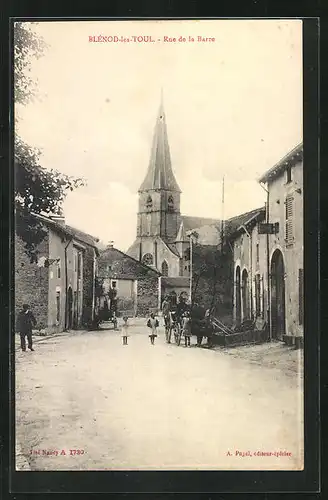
[16,20,303,251]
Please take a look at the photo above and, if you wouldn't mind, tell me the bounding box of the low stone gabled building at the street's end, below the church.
[97,246,160,316]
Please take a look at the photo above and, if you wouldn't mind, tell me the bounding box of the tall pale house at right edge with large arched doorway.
[259,143,304,341]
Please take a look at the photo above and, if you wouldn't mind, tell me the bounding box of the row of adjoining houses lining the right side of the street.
[228,144,304,342]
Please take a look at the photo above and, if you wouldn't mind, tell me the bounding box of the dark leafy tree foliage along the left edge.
[14,22,84,262]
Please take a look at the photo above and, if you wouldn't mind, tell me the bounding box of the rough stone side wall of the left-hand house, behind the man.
[15,235,49,330]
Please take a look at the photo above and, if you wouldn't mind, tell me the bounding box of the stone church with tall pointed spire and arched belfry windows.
[127,95,220,293]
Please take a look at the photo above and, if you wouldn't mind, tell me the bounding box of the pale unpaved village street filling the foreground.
[16,319,302,470]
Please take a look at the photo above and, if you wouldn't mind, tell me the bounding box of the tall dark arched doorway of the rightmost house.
[271,249,286,340]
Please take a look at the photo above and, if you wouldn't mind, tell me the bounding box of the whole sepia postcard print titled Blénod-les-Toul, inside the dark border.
[14,19,304,471]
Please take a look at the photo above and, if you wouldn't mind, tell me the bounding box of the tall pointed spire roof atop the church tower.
[139,96,181,193]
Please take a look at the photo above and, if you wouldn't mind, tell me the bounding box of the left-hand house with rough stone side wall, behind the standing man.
[15,215,98,333]
